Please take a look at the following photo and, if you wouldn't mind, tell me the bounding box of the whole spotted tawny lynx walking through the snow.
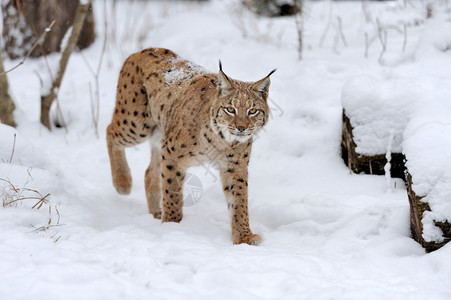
[107,48,275,245]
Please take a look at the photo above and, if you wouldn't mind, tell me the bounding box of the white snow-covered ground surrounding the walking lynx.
[0,1,451,300]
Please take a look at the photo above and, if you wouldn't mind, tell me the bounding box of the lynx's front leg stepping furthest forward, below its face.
[221,166,262,245]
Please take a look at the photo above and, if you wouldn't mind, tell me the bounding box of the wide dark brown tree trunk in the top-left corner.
[2,0,95,58]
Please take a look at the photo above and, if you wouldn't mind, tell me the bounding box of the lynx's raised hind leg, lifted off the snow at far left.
[107,124,132,195]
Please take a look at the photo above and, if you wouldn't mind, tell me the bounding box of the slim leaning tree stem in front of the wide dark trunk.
[41,1,91,130]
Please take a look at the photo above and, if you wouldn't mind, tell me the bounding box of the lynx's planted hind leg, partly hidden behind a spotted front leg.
[145,132,162,219]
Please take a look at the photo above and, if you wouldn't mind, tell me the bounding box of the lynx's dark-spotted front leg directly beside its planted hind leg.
[161,152,185,222]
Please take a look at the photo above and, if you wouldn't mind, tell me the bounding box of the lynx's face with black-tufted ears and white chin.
[211,70,272,143]
